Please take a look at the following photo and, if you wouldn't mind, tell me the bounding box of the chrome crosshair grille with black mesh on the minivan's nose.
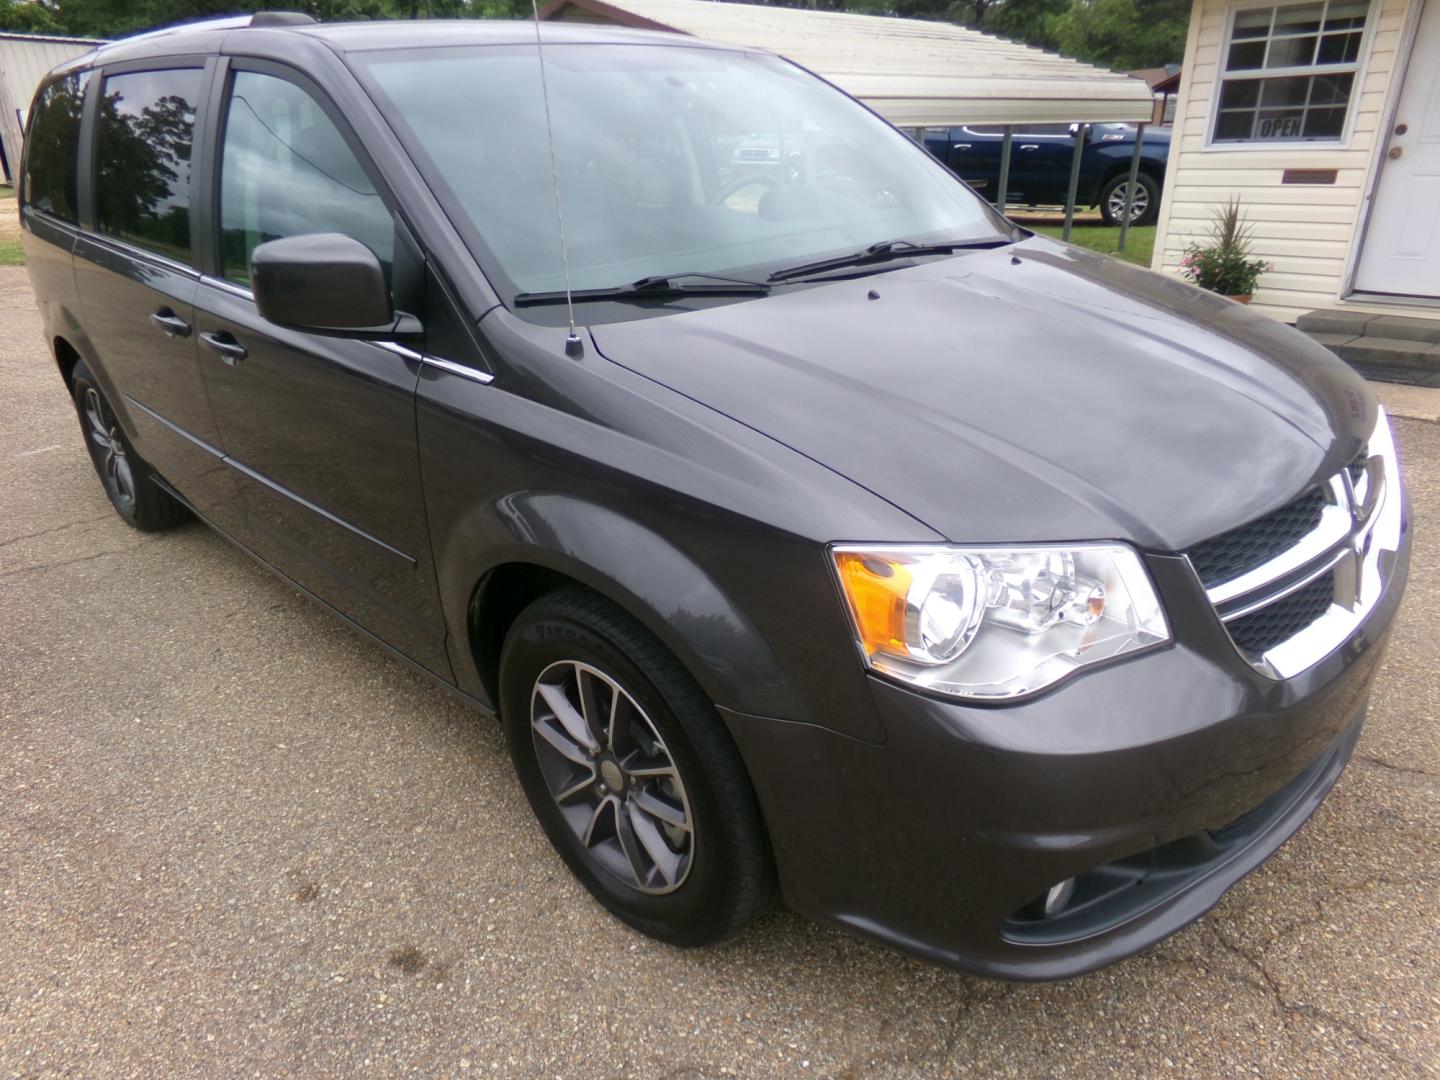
[1187,410,1404,678]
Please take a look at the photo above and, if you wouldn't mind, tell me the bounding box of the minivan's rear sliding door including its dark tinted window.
[73,58,238,531]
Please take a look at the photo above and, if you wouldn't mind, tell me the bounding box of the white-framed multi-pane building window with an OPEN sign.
[1211,0,1369,143]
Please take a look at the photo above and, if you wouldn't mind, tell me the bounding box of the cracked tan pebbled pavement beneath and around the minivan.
[0,269,1440,1080]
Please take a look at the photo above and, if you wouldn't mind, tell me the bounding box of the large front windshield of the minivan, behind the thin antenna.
[348,43,1009,302]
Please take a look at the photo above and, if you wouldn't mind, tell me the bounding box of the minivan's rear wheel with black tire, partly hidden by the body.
[71,360,190,533]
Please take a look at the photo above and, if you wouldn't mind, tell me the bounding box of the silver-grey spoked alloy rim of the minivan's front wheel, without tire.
[530,661,696,894]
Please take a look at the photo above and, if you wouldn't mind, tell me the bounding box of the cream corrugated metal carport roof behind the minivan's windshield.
[541,0,1153,127]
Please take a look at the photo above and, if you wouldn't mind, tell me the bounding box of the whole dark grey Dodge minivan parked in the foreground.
[20,14,1410,979]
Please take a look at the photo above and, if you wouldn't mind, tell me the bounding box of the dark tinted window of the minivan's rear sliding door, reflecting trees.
[95,68,202,262]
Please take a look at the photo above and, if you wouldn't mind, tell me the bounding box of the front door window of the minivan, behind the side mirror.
[220,72,395,281]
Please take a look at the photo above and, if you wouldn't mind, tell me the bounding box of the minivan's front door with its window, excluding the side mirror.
[196,62,451,678]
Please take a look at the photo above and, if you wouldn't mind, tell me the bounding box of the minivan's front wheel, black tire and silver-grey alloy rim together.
[500,589,772,945]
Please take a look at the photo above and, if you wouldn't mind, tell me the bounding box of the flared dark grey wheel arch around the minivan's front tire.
[436,491,802,728]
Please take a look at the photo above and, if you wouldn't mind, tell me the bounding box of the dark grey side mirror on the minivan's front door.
[251,232,420,337]
